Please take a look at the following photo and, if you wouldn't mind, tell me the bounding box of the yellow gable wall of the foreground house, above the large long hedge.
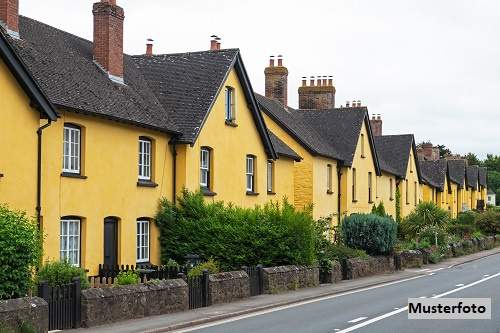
[177,70,294,207]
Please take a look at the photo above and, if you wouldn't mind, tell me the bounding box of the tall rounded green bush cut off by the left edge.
[0,205,42,299]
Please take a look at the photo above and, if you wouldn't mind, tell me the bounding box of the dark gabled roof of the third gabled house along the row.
[373,134,421,179]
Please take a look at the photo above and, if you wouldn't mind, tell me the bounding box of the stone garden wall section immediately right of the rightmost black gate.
[263,265,319,294]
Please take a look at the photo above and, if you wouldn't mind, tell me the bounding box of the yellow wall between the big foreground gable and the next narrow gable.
[263,114,338,223]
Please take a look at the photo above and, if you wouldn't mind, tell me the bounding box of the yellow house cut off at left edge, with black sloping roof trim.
[0,31,57,217]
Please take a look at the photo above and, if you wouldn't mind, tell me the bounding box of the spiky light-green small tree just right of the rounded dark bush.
[401,202,449,244]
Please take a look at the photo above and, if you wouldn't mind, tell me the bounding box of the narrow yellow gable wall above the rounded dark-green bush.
[341,122,377,215]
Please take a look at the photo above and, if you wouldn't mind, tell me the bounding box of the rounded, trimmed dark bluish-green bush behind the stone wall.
[342,214,397,255]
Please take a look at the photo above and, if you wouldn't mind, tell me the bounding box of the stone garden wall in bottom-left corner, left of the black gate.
[0,297,49,333]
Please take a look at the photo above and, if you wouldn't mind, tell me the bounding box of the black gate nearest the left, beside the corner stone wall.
[38,278,81,331]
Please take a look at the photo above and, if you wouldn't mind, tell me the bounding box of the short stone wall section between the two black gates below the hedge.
[208,271,250,305]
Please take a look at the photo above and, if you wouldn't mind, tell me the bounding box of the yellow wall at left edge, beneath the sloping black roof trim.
[0,60,40,216]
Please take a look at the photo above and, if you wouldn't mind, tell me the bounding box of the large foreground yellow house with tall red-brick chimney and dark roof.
[0,0,300,275]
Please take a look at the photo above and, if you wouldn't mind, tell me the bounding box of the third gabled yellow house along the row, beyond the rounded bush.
[374,134,422,218]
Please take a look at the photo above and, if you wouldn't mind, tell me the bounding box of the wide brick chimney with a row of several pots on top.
[299,76,336,110]
